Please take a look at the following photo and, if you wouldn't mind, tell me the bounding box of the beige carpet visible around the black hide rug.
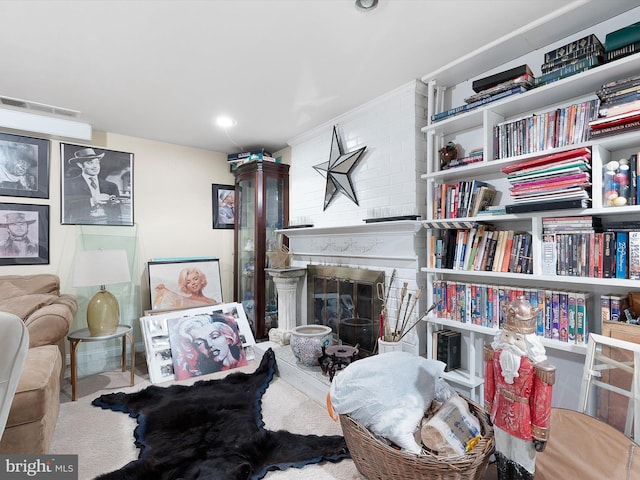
[51,352,364,480]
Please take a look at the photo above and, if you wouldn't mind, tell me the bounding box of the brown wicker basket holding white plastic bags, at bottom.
[340,399,495,480]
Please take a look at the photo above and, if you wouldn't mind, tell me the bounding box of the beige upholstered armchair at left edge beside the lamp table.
[0,274,77,454]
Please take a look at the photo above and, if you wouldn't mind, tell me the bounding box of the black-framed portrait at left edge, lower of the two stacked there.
[0,203,49,265]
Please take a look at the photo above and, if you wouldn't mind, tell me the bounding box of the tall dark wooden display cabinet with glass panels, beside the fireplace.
[233,162,289,340]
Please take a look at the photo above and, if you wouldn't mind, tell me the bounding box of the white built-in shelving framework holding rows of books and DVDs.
[420,0,640,408]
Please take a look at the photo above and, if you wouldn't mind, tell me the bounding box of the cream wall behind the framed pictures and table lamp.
[0,128,242,374]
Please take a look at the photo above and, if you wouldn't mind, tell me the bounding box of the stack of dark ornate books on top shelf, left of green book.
[535,34,605,87]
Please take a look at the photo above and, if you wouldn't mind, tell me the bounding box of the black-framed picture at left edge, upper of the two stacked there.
[0,133,49,198]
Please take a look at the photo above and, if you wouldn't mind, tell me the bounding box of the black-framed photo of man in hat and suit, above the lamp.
[60,143,133,226]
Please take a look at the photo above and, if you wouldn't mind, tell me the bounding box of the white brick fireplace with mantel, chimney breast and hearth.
[252,80,428,404]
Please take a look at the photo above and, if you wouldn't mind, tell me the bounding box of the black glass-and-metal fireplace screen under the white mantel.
[307,265,384,356]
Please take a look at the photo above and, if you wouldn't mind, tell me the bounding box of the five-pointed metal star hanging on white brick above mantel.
[313,126,367,210]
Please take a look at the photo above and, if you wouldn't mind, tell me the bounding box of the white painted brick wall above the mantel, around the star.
[289,81,426,227]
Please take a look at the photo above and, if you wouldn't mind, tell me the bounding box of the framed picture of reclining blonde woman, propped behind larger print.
[147,258,223,310]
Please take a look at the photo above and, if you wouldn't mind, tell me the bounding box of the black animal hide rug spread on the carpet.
[92,349,349,480]
